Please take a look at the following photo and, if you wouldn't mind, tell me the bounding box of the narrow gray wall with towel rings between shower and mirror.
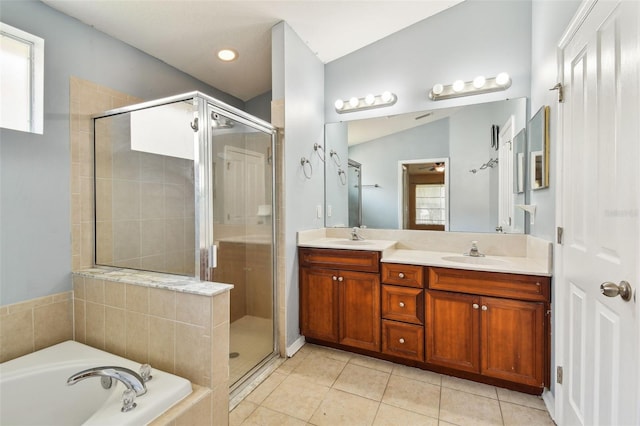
[272,22,325,346]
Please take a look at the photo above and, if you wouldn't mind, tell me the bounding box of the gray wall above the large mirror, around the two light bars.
[325,0,531,122]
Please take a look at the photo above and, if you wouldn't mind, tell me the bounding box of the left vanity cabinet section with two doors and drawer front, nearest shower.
[298,248,381,352]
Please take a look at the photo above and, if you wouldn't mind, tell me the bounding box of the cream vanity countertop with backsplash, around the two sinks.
[298,228,553,276]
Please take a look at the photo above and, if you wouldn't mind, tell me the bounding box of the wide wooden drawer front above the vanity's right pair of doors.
[429,268,551,302]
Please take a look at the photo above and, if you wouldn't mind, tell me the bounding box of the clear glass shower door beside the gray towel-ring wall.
[208,106,275,389]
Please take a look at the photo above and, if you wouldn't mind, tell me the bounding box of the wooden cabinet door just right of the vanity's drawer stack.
[425,290,480,373]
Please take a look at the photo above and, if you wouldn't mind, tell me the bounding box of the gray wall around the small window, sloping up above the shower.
[0,0,244,305]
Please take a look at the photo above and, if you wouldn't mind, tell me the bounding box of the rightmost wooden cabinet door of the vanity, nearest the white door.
[481,297,546,386]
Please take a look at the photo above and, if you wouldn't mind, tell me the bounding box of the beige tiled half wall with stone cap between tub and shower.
[73,267,232,425]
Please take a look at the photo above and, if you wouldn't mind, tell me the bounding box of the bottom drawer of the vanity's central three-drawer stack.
[382,320,424,361]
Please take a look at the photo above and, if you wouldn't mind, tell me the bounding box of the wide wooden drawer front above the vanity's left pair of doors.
[298,247,380,272]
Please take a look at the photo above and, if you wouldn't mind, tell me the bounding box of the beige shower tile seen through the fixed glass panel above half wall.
[95,114,195,275]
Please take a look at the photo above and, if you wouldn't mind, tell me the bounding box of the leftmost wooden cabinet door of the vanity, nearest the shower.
[300,268,338,342]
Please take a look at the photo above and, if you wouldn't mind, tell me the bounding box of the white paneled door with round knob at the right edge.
[552,0,640,425]
